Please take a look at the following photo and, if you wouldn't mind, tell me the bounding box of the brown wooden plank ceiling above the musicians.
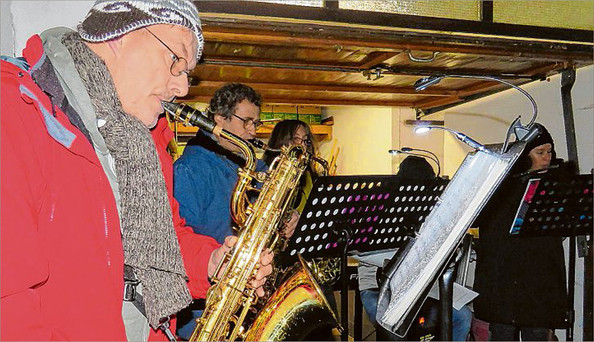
[181,1,593,113]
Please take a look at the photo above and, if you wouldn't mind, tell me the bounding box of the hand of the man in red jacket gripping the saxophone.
[208,235,274,297]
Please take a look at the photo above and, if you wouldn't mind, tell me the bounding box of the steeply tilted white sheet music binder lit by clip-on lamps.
[376,142,525,332]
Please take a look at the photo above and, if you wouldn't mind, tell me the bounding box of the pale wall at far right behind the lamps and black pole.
[444,66,594,173]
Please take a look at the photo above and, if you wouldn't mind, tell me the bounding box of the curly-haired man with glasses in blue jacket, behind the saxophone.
[174,83,299,339]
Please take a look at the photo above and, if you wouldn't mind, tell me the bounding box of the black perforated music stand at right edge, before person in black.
[510,174,594,341]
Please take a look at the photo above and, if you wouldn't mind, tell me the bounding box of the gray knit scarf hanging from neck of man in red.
[63,33,192,328]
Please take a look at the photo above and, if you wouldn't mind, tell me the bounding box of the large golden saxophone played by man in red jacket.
[163,102,340,341]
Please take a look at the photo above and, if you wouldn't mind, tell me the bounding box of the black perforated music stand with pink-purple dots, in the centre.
[284,175,447,341]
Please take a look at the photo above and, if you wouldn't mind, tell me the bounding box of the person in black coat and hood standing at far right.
[474,124,567,341]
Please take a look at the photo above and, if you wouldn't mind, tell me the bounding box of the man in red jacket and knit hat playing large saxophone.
[0,0,272,341]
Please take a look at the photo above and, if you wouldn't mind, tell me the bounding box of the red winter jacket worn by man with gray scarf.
[0,36,219,341]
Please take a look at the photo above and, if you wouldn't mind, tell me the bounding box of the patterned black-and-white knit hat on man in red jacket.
[78,0,204,60]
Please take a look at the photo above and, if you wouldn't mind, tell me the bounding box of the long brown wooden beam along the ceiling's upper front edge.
[203,19,593,63]
